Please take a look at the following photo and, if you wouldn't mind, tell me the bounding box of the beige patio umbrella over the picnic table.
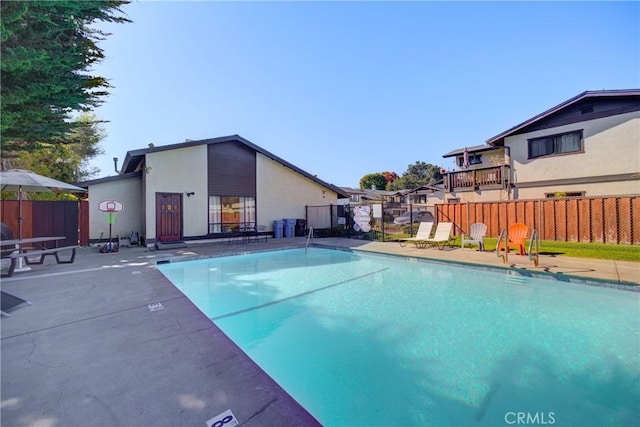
[0,169,86,239]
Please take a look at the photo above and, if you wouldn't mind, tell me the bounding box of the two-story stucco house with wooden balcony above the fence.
[443,89,640,202]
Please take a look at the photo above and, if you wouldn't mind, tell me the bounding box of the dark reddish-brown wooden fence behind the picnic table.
[0,200,89,246]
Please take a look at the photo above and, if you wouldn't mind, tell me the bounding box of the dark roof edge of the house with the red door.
[121,135,349,199]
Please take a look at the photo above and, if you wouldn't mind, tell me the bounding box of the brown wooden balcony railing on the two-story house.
[443,165,509,193]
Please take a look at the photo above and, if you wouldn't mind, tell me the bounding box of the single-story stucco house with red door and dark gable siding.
[80,135,348,246]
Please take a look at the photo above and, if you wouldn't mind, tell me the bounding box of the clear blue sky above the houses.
[93,1,640,188]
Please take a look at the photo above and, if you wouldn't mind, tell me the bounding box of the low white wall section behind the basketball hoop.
[89,177,144,241]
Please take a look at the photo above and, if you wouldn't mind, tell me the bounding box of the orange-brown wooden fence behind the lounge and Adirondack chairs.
[435,195,640,245]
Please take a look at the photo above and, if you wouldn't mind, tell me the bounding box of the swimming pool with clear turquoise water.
[158,248,640,426]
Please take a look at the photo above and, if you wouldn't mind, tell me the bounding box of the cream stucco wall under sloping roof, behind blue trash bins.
[256,153,337,230]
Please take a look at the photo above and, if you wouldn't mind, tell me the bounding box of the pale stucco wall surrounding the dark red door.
[145,144,209,239]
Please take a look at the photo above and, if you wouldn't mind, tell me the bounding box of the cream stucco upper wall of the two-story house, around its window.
[505,111,640,199]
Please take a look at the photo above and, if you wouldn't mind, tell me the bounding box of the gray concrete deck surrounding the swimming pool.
[0,238,640,427]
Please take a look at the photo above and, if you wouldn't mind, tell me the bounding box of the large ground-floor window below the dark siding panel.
[209,196,256,233]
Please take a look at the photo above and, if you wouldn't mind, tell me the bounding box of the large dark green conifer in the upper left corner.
[0,0,130,157]
